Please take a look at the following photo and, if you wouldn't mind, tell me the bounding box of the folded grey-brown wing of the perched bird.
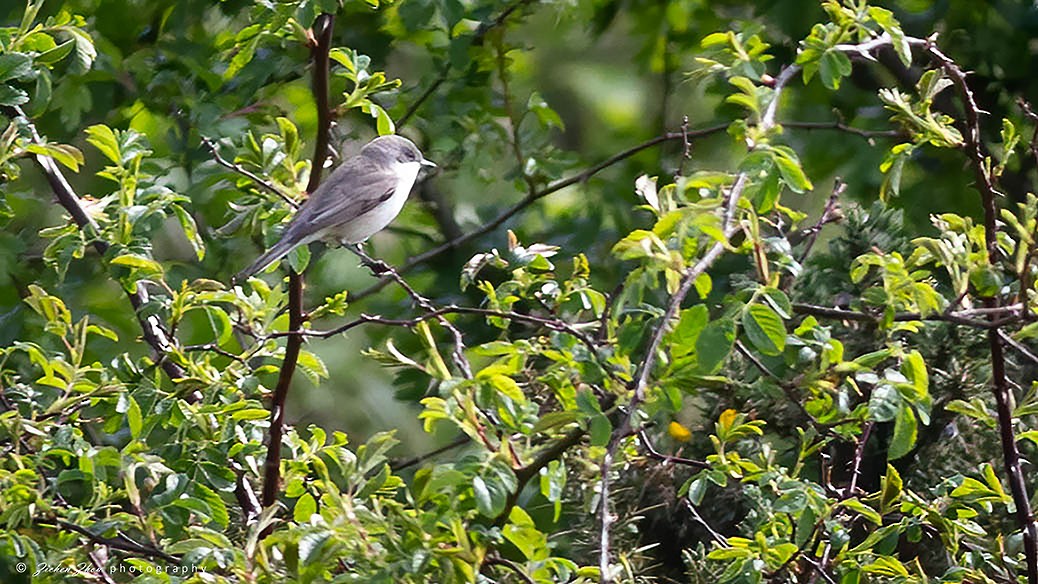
[284,157,397,241]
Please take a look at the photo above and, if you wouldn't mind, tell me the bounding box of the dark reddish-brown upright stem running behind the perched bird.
[263,13,334,512]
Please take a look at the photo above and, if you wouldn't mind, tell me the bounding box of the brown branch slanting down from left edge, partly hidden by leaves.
[0,106,187,387]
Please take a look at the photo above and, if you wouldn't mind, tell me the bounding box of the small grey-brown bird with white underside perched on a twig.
[233,135,436,282]
